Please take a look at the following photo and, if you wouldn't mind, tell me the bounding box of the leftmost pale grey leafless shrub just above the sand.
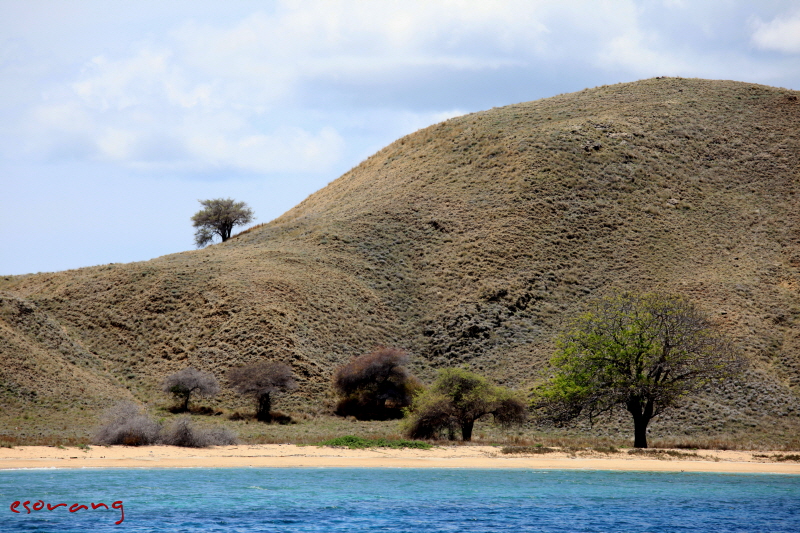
[92,402,161,446]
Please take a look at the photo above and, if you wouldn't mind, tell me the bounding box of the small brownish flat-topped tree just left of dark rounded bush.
[228,361,297,422]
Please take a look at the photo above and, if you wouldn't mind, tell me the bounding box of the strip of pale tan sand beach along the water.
[0,444,800,474]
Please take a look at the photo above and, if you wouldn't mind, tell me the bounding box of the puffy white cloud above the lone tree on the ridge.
[33,38,344,173]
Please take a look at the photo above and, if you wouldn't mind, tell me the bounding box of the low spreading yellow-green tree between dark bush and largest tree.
[407,368,526,441]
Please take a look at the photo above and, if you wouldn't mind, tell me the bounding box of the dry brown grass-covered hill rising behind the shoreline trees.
[0,78,800,442]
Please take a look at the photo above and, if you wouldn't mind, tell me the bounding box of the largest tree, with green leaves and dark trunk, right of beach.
[533,292,744,448]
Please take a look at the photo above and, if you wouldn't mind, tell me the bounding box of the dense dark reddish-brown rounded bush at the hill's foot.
[333,347,422,420]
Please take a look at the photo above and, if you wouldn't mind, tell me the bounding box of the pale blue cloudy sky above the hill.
[0,0,800,275]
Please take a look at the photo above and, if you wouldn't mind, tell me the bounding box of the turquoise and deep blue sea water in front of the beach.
[0,468,800,533]
